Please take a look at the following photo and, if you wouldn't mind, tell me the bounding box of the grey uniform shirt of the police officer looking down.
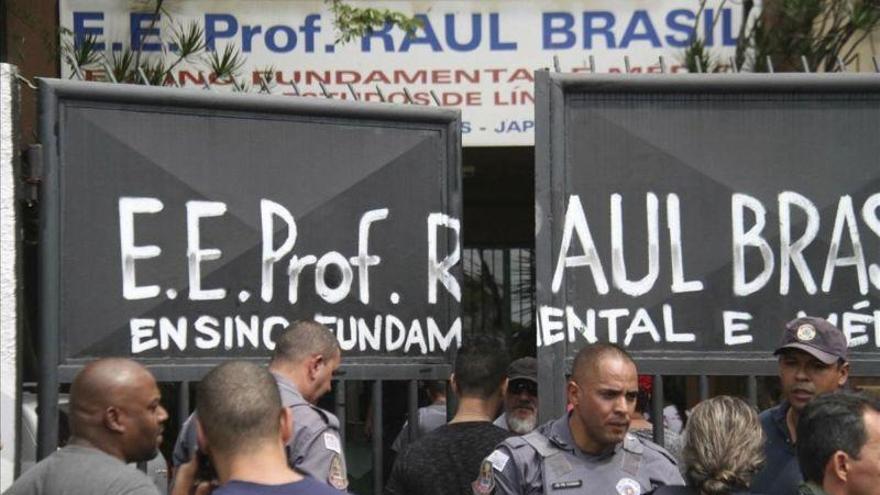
[172,373,348,490]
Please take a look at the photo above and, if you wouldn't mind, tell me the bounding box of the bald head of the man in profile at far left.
[70,358,168,462]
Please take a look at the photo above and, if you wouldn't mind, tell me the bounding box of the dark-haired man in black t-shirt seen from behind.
[385,336,511,495]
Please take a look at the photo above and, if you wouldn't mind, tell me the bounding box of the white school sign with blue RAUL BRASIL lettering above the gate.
[59,0,740,146]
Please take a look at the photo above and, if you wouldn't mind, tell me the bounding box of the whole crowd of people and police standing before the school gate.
[4,317,880,495]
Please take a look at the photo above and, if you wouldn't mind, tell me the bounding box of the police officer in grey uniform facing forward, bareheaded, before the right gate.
[474,344,684,495]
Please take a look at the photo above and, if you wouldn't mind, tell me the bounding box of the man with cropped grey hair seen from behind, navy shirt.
[189,361,340,495]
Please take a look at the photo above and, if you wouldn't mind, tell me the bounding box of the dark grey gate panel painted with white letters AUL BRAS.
[536,72,880,379]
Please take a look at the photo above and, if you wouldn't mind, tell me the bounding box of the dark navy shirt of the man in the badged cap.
[752,402,804,495]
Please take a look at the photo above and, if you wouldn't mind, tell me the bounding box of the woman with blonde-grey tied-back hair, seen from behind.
[653,395,764,495]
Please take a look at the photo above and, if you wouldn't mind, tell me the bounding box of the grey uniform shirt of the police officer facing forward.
[484,415,684,495]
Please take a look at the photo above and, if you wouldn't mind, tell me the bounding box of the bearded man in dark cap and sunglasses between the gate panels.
[495,357,538,435]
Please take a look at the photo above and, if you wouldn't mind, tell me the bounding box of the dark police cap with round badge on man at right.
[773,316,847,364]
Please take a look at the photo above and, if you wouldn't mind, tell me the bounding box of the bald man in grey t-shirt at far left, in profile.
[4,358,168,495]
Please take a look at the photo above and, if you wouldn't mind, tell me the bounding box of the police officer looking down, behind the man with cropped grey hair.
[172,320,348,490]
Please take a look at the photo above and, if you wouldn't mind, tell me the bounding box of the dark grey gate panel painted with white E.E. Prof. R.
[41,81,461,379]
